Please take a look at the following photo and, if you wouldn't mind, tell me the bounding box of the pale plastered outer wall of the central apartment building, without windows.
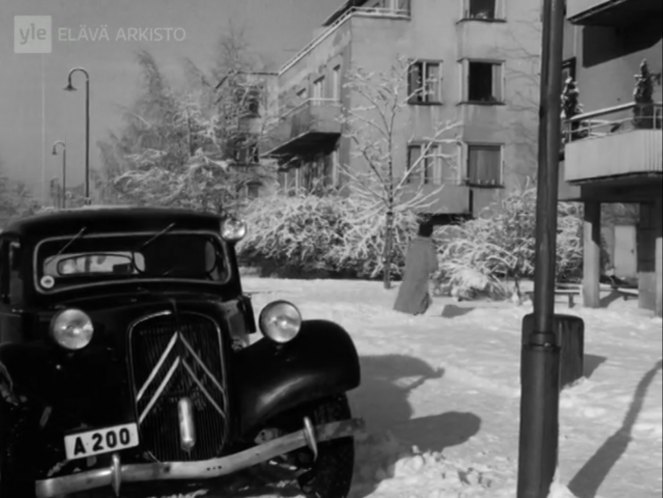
[279,0,541,217]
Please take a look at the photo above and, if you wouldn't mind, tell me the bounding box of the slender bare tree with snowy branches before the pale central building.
[343,56,458,288]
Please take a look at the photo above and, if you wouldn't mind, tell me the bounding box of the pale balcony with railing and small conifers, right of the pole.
[563,102,663,183]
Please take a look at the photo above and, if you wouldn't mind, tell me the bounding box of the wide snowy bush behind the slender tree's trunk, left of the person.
[238,195,415,278]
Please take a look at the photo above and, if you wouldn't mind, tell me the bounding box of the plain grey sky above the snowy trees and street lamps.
[0,0,341,202]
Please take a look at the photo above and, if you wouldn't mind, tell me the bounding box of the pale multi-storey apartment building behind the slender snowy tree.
[269,0,541,222]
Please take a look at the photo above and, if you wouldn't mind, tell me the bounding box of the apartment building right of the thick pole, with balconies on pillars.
[560,0,663,316]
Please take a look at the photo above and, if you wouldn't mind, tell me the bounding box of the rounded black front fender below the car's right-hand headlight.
[234,320,360,432]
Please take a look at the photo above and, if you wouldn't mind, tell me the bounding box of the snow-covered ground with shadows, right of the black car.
[236,276,663,498]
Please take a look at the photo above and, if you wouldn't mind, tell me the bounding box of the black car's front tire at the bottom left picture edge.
[0,399,35,498]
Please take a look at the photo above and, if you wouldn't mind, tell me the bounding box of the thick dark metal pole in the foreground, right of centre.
[518,0,564,498]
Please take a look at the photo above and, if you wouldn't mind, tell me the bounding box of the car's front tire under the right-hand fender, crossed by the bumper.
[298,394,355,498]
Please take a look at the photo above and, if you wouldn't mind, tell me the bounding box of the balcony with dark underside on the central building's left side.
[267,99,341,156]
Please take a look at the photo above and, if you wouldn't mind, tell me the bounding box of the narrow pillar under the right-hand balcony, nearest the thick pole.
[582,201,601,308]
